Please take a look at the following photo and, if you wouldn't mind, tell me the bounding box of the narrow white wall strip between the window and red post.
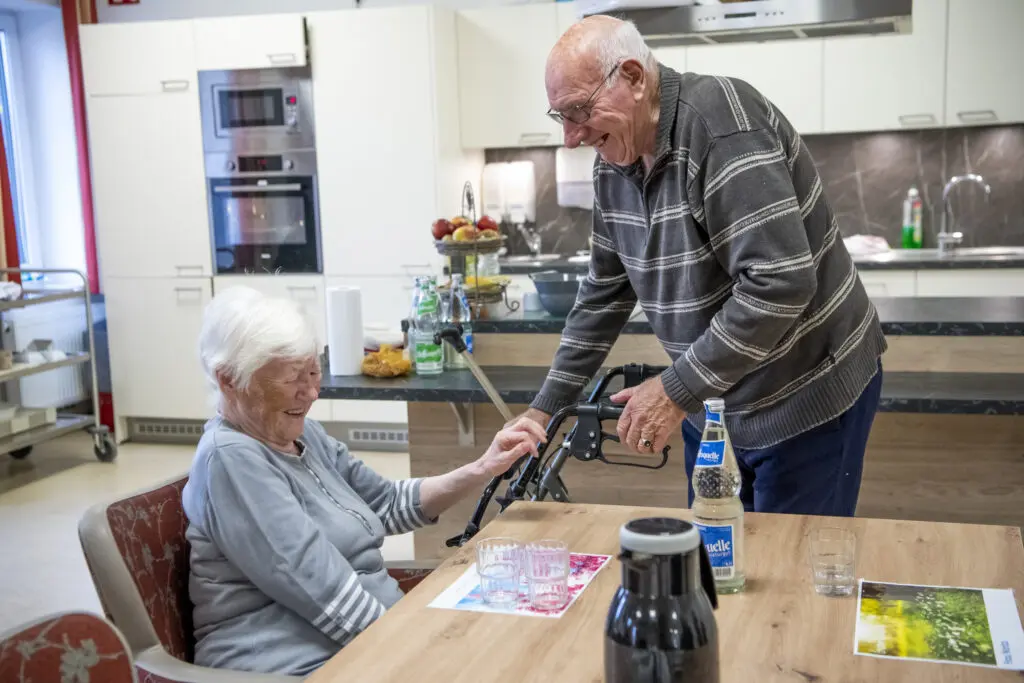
[16,7,85,278]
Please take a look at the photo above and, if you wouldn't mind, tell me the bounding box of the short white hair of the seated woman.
[199,287,319,408]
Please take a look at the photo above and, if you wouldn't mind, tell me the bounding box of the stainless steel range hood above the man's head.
[575,0,927,47]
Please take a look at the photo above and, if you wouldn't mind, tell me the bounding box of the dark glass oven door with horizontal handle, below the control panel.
[210,176,321,273]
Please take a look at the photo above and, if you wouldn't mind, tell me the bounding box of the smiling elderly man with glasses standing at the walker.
[527,16,886,515]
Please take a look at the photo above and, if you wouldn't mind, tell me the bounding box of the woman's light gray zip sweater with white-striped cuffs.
[181,418,434,676]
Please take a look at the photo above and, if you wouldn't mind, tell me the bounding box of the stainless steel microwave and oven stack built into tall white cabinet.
[193,68,323,273]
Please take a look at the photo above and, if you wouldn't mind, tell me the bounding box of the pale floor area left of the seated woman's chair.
[0,433,194,632]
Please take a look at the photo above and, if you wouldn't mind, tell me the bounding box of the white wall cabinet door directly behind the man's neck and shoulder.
[685,39,824,134]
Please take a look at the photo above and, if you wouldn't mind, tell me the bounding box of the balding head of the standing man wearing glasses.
[544,14,658,165]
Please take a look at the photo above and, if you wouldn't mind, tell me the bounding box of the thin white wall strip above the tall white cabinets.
[96,0,552,24]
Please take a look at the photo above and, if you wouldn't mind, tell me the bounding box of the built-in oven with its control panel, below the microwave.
[207,152,323,273]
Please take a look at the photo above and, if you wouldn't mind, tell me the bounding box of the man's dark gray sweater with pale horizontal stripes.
[534,66,886,449]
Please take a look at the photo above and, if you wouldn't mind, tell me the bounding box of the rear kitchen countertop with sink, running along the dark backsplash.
[501,247,1024,275]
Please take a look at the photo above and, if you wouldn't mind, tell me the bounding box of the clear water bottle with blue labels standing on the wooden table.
[693,398,746,593]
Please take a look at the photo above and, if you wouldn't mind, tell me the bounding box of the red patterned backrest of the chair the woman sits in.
[79,477,195,661]
